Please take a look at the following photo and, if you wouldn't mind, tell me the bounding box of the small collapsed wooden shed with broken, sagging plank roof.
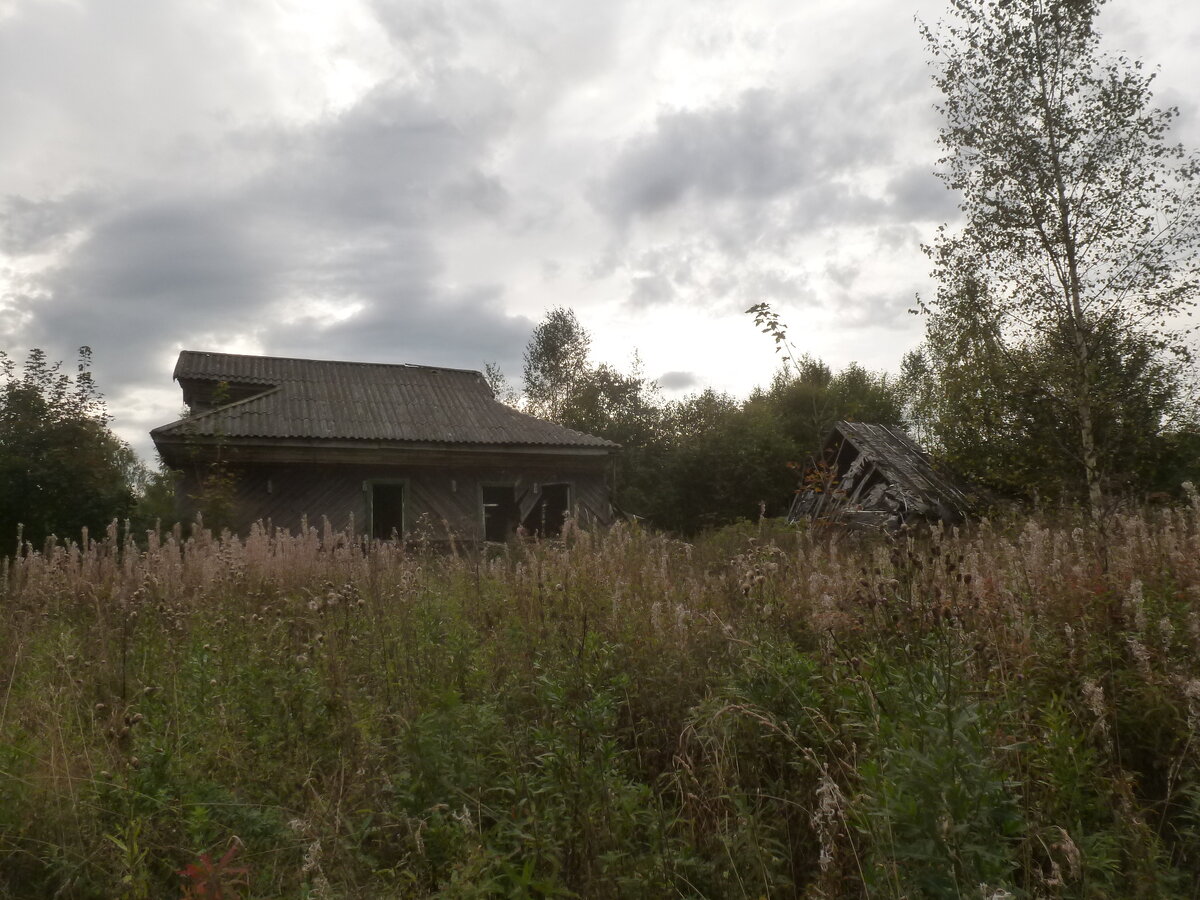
[788,421,976,528]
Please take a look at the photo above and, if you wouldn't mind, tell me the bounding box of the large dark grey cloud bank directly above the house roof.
[5,70,532,441]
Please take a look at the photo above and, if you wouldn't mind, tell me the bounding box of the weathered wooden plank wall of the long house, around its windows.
[178,461,612,540]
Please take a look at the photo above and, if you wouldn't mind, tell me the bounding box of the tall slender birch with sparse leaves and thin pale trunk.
[922,0,1200,515]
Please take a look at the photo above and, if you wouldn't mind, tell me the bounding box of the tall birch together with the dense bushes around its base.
[908,0,1200,515]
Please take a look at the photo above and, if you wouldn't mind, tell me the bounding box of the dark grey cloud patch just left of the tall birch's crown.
[590,80,928,321]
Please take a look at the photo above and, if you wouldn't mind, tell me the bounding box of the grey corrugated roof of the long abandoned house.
[150,350,617,448]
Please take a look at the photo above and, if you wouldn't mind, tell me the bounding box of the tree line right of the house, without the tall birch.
[488,292,1200,534]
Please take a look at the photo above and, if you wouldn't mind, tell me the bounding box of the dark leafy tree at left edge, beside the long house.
[0,347,140,556]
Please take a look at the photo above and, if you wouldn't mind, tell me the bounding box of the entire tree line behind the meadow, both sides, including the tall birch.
[0,0,1200,548]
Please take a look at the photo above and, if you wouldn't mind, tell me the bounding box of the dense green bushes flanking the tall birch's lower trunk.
[900,286,1200,502]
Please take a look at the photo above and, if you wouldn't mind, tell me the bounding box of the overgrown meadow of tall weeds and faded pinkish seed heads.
[0,503,1200,899]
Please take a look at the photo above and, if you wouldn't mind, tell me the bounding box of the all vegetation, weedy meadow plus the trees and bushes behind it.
[0,0,1200,900]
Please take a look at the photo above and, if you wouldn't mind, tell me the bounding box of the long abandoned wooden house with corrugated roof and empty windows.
[150,350,618,541]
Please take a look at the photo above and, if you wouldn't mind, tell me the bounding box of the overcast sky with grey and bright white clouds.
[0,0,1200,456]
